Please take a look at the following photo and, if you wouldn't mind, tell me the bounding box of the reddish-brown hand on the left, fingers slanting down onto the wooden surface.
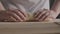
[0,9,27,22]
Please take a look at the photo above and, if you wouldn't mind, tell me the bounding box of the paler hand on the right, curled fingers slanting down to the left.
[34,9,56,21]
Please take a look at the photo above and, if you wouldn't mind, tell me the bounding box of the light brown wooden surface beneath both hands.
[0,20,60,34]
